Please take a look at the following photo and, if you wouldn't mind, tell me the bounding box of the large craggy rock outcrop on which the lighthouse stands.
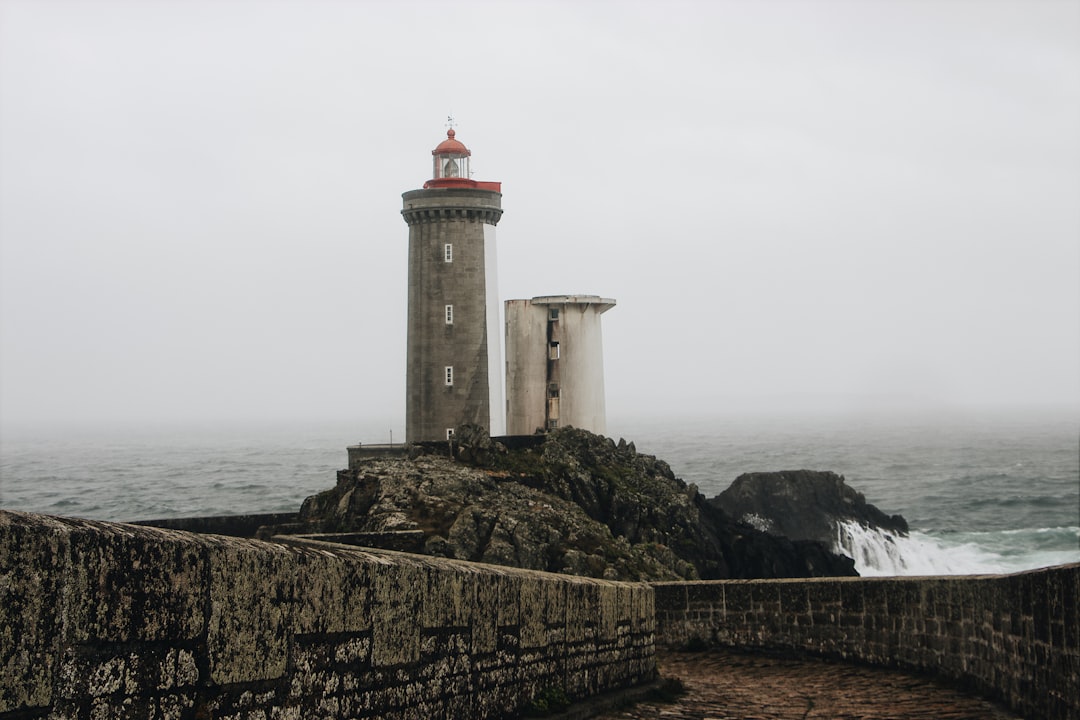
[289,427,855,580]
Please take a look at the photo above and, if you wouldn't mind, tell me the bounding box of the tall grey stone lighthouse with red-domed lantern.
[402,128,505,443]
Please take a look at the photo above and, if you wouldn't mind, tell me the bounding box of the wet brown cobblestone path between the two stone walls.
[599,651,1020,720]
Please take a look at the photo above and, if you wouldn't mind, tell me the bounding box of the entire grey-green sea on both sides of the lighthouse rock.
[0,412,1080,575]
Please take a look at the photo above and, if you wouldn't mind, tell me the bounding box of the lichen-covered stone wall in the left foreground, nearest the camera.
[0,512,654,720]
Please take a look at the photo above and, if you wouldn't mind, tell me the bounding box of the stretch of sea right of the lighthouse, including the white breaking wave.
[620,413,1080,575]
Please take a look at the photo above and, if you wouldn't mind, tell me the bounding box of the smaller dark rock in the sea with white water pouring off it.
[710,470,907,543]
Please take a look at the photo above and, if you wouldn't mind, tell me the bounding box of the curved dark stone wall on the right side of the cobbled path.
[653,565,1080,718]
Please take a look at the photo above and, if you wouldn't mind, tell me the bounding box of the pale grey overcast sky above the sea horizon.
[0,0,1080,427]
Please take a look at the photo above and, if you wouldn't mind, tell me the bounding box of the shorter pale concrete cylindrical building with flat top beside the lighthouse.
[507,295,615,435]
